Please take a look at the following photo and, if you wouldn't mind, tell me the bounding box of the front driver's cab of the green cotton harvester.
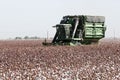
[52,24,72,44]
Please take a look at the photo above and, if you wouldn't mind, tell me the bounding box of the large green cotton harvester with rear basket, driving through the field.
[43,15,106,45]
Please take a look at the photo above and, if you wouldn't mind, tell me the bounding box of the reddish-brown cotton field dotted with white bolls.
[0,39,120,80]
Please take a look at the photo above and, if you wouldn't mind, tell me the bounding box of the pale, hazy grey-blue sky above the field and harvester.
[0,0,120,39]
